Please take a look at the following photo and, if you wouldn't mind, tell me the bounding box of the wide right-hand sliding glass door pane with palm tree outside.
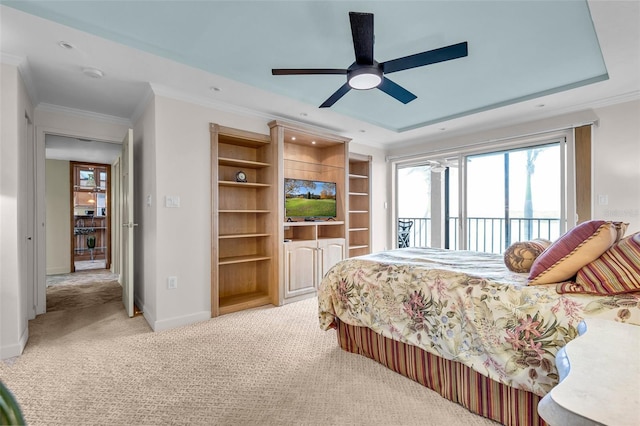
[466,143,563,253]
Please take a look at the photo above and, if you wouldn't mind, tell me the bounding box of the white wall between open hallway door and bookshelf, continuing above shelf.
[142,94,269,330]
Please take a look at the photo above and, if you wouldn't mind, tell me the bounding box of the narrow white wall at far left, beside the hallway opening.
[0,63,33,359]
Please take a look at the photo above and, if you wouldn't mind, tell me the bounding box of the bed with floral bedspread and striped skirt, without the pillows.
[318,233,640,425]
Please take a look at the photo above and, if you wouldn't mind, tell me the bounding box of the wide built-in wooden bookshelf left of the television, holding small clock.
[210,124,281,316]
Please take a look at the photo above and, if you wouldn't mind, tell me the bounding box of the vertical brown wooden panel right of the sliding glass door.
[574,125,592,223]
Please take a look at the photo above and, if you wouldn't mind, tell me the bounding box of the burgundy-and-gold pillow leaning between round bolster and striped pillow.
[529,220,620,285]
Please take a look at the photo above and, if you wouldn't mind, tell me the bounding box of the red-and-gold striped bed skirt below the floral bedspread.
[335,318,546,426]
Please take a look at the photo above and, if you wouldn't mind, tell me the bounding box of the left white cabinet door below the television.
[284,240,318,299]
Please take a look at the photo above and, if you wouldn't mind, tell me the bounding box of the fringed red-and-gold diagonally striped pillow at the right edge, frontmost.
[556,232,640,294]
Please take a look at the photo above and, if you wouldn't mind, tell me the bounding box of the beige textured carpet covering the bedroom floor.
[0,299,495,425]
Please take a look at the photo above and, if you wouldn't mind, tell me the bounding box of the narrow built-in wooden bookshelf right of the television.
[349,153,371,257]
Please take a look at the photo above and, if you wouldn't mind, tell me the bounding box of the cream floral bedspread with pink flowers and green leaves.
[318,248,640,396]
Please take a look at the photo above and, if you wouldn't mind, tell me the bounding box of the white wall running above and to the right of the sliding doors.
[389,101,640,234]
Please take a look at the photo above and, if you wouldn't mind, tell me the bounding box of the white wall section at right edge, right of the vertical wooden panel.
[592,101,640,234]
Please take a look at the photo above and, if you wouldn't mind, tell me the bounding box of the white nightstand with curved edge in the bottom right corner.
[538,319,640,426]
